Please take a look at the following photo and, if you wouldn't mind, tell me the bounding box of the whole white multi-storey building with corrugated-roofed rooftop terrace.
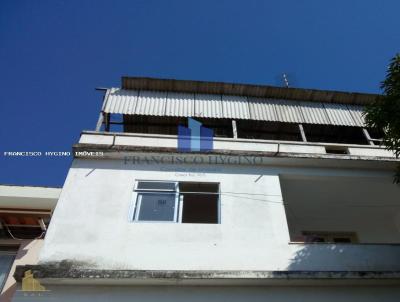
[14,78,400,301]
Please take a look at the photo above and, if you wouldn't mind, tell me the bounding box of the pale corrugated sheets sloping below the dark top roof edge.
[104,88,364,127]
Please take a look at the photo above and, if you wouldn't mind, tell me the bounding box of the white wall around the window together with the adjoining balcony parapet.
[40,159,400,270]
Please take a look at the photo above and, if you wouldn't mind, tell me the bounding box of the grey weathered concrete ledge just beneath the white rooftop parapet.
[73,143,400,170]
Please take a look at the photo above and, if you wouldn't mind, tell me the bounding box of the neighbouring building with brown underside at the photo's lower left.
[0,185,61,302]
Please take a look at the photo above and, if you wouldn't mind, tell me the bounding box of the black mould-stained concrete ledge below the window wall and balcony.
[14,263,400,286]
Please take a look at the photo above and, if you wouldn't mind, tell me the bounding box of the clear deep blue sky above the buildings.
[0,0,400,186]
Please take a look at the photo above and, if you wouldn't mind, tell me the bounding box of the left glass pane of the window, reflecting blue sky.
[138,193,176,221]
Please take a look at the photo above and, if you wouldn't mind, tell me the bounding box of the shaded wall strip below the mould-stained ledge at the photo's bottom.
[13,286,400,302]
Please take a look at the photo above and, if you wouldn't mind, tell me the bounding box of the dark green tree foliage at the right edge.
[365,54,400,183]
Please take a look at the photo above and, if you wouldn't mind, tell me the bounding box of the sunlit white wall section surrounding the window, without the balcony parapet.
[41,160,289,269]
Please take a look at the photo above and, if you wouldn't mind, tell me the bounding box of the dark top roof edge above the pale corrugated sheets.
[121,76,382,105]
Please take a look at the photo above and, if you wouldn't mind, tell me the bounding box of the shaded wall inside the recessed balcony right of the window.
[281,175,400,243]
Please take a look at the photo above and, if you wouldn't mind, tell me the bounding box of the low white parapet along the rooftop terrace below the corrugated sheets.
[79,131,397,161]
